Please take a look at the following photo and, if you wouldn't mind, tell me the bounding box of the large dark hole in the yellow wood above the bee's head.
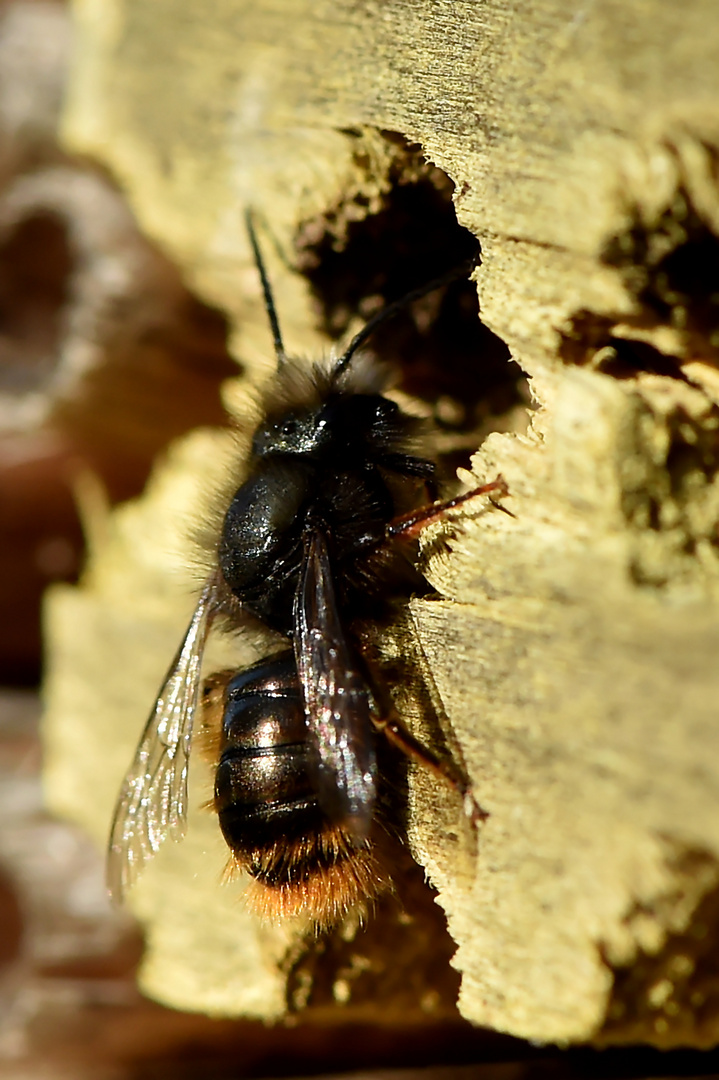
[298,136,526,473]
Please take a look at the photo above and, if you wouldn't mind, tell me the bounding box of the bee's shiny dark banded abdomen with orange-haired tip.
[215,652,383,926]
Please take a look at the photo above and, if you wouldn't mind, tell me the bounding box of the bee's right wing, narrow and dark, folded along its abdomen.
[294,529,377,837]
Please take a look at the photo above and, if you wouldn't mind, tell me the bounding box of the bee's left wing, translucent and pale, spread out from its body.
[107,583,214,900]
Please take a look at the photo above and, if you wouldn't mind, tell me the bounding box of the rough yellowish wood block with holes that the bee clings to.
[46,0,719,1044]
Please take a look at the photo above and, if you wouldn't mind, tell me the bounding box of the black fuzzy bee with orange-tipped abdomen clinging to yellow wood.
[108,213,506,927]
